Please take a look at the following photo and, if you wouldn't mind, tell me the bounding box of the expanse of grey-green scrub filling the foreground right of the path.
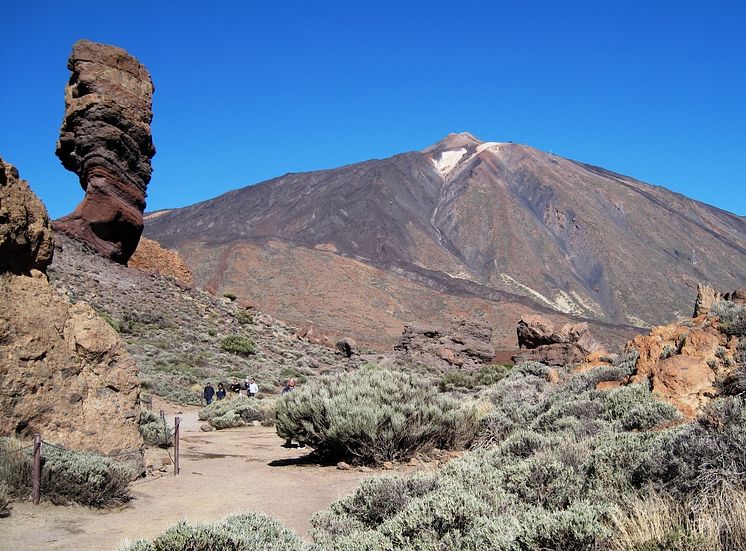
[123,340,746,551]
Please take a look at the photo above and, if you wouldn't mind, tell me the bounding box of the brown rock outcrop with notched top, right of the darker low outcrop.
[513,315,601,366]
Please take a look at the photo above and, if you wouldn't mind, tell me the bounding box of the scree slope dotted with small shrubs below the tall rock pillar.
[49,234,366,404]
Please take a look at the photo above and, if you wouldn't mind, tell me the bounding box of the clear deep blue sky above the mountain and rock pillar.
[0,0,746,217]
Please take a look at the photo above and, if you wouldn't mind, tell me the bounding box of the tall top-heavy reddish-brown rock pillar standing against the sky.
[54,40,155,264]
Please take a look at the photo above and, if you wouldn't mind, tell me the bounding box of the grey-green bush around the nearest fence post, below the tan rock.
[0,438,133,507]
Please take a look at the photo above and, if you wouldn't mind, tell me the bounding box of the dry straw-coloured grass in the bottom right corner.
[610,490,746,551]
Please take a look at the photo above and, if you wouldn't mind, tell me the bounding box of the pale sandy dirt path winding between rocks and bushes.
[0,409,369,551]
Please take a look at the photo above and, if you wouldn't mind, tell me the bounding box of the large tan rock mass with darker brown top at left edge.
[0,158,142,465]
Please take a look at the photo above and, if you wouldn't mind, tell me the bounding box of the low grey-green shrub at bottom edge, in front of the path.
[118,513,304,551]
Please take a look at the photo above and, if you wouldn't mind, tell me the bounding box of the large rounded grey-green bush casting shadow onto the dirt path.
[277,367,476,464]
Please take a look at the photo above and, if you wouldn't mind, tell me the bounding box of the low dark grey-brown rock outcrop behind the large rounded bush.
[394,320,495,370]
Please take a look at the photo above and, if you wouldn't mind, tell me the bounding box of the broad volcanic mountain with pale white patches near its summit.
[145,133,746,347]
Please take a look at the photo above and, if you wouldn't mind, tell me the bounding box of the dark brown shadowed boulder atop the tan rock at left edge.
[0,159,54,274]
